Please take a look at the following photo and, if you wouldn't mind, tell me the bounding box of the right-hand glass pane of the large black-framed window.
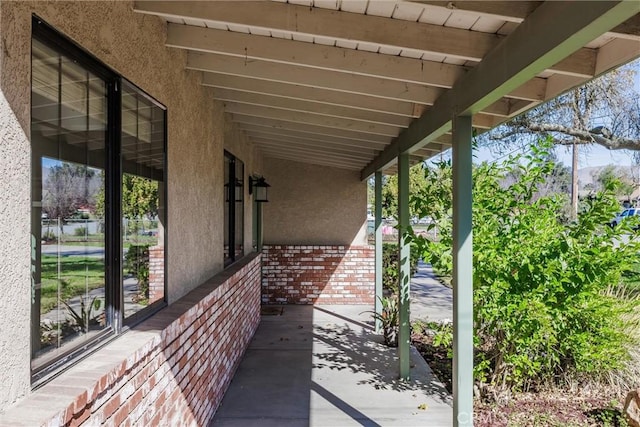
[121,82,166,318]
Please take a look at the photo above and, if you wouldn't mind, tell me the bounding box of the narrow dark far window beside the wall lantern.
[224,151,244,266]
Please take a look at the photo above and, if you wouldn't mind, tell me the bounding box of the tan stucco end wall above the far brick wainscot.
[263,158,367,246]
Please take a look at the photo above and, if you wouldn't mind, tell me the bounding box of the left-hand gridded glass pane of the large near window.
[31,40,107,368]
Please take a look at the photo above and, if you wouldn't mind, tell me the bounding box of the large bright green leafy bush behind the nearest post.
[412,140,640,390]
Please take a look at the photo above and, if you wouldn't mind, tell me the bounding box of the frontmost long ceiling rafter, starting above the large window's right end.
[134,1,592,75]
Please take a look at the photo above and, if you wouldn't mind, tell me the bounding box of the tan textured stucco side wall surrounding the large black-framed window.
[0,1,258,411]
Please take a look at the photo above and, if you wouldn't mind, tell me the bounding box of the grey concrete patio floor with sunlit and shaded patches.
[211,305,452,427]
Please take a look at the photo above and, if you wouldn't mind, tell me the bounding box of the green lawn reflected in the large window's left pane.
[40,255,104,313]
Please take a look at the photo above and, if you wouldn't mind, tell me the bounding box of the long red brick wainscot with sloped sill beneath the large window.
[0,256,260,426]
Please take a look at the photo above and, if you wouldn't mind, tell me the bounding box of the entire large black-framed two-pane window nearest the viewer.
[31,17,166,382]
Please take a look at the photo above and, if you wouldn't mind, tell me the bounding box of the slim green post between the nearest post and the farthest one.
[398,153,411,380]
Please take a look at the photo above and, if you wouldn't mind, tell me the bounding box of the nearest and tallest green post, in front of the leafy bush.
[453,116,473,426]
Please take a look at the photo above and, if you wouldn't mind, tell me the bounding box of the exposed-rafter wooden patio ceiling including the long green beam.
[135,0,640,179]
